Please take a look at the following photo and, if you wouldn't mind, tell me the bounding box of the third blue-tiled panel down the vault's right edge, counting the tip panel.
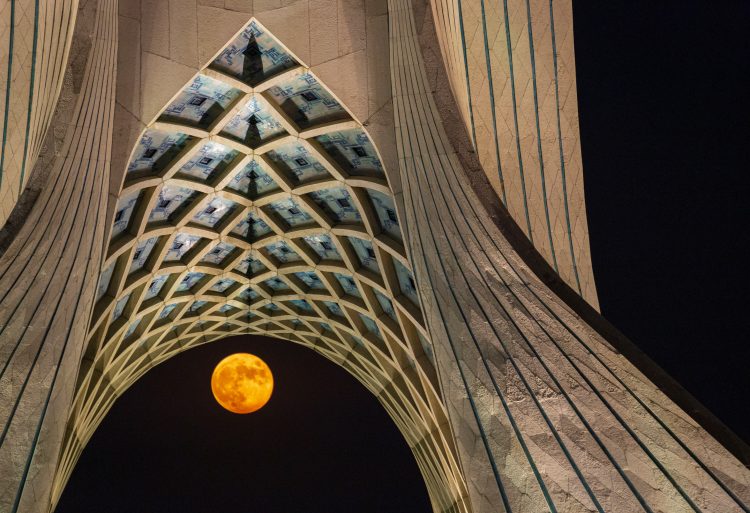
[316,128,383,176]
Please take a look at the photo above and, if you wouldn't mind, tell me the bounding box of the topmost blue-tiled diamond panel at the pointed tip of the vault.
[211,22,297,85]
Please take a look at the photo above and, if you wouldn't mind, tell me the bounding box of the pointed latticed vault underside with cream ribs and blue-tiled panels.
[53,21,467,511]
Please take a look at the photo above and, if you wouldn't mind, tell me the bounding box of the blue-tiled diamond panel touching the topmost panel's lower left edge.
[161,75,240,128]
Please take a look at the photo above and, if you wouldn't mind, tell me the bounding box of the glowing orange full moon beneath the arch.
[211,353,273,413]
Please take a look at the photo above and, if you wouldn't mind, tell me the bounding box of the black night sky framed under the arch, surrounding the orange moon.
[55,335,431,513]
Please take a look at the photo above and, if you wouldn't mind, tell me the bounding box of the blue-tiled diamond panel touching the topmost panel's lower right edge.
[268,72,348,128]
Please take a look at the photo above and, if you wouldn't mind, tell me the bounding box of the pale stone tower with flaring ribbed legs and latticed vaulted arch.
[0,0,750,513]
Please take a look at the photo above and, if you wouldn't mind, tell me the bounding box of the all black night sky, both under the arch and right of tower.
[57,0,750,513]
